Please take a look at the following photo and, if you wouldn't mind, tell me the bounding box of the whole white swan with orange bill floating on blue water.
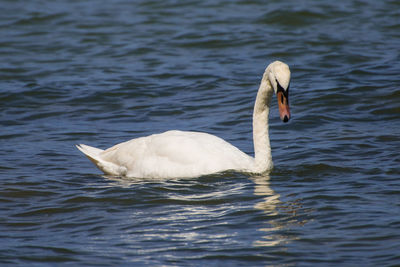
[76,61,290,178]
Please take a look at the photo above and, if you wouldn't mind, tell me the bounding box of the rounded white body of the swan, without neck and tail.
[82,130,254,178]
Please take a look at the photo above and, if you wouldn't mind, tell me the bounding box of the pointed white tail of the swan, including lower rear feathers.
[76,144,126,175]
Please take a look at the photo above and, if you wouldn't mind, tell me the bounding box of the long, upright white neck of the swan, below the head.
[253,75,273,172]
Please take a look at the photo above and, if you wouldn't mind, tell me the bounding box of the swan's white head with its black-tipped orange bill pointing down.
[266,61,290,122]
